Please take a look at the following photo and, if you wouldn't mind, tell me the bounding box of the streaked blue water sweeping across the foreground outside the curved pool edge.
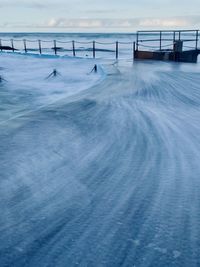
[0,56,200,267]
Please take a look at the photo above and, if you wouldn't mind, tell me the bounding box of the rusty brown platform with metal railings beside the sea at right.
[134,30,200,63]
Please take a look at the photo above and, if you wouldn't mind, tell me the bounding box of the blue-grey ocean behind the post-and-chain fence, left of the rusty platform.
[0,33,135,58]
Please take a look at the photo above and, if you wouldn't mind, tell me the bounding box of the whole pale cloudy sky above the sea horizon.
[0,0,200,32]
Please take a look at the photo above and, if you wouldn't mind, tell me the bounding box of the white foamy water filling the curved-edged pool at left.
[0,53,103,121]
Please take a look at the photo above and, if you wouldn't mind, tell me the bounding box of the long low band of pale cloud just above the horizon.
[0,16,200,32]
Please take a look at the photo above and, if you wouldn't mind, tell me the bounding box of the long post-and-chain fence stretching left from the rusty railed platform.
[0,39,136,59]
